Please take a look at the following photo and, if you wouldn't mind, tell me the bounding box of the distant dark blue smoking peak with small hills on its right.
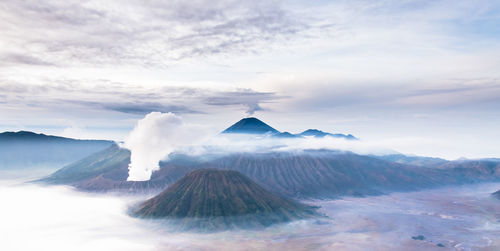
[222,117,357,140]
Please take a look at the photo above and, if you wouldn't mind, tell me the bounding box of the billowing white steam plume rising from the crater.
[124,112,207,181]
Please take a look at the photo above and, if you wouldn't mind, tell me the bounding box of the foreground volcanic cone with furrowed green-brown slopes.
[135,169,317,230]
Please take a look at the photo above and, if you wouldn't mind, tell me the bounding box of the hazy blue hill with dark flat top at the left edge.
[0,131,113,170]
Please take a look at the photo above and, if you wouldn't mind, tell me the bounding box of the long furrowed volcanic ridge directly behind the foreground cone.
[41,146,500,198]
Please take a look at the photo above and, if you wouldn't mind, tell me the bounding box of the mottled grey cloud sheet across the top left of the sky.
[0,0,320,67]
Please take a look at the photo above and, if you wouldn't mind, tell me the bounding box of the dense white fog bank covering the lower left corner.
[0,184,160,250]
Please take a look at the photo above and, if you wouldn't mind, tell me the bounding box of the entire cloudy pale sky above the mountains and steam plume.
[0,0,500,159]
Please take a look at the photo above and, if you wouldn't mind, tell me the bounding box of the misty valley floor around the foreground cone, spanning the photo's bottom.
[0,176,500,250]
